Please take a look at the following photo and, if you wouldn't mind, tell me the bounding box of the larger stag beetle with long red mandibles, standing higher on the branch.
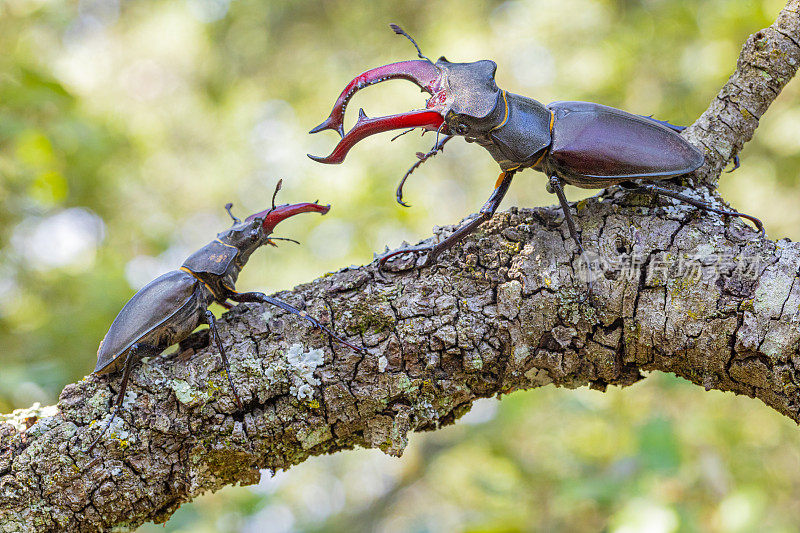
[309,24,764,266]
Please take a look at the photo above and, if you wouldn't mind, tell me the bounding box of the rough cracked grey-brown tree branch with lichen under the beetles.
[0,0,800,532]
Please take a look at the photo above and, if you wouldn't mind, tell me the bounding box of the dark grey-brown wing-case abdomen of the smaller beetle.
[94,270,202,374]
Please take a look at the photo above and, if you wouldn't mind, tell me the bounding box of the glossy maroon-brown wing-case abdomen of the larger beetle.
[544,102,704,188]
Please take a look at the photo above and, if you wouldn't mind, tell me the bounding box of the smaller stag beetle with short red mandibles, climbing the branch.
[86,181,362,452]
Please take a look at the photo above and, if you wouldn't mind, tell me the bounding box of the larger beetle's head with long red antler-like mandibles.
[309,24,505,163]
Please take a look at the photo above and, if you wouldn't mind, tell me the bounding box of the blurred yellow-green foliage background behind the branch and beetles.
[0,0,800,532]
